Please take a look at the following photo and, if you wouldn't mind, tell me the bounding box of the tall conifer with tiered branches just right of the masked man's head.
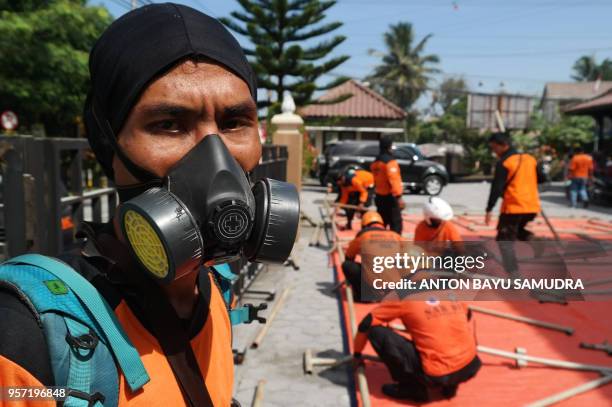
[221,0,350,114]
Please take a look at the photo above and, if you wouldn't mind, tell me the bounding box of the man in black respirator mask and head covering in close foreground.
[0,3,299,406]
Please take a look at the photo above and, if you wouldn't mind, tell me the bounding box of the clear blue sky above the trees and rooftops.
[92,0,612,100]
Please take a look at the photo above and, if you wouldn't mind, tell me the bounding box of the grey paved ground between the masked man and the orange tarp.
[234,191,350,407]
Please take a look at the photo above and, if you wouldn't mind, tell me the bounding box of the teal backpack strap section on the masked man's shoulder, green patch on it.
[0,254,150,407]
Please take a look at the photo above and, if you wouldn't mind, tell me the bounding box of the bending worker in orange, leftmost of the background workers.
[337,167,374,230]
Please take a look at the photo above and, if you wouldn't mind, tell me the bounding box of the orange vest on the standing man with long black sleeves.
[501,154,540,214]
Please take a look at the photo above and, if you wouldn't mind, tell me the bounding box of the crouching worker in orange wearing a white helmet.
[414,197,464,255]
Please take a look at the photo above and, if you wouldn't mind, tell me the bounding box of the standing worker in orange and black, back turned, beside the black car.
[370,136,405,235]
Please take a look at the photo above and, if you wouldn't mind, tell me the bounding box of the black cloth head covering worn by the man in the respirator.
[83,3,257,182]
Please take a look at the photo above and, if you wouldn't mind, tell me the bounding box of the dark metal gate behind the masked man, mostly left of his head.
[0,136,287,270]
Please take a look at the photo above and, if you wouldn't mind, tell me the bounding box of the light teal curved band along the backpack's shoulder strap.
[3,254,150,391]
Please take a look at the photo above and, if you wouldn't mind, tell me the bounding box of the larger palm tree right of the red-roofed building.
[367,22,440,110]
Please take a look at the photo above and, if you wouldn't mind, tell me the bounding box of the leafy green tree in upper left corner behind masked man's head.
[0,0,111,136]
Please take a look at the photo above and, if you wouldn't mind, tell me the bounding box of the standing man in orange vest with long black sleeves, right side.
[485,133,543,274]
